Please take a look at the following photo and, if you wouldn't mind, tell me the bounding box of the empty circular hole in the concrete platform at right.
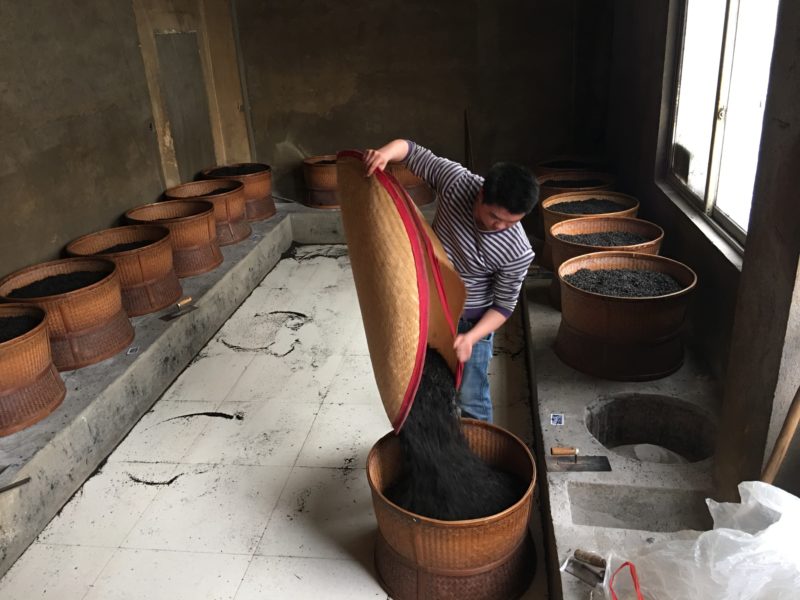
[586,394,716,463]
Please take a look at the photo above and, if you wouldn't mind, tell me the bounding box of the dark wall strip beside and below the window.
[608,0,740,378]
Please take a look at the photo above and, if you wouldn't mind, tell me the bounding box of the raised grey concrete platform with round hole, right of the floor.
[524,278,720,600]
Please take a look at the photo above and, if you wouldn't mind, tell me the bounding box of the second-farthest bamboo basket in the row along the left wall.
[164,179,251,246]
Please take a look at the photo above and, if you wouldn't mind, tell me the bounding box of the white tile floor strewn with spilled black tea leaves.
[0,246,545,600]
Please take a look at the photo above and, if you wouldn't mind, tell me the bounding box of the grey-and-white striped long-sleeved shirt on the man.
[406,140,533,321]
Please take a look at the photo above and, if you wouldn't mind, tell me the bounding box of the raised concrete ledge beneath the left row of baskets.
[0,203,435,576]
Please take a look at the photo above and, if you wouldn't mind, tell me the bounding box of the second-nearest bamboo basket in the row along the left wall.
[0,258,134,371]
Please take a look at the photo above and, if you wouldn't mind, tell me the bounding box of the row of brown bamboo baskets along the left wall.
[0,163,275,435]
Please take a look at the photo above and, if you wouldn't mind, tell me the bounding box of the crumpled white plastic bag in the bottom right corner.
[603,481,800,600]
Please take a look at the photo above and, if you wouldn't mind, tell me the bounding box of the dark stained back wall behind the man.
[236,0,592,199]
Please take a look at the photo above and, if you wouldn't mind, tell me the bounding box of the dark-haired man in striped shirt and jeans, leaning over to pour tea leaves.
[364,139,539,422]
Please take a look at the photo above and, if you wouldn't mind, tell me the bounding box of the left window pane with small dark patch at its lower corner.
[672,0,725,198]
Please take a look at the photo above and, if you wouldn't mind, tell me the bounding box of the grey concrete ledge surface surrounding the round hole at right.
[523,278,720,600]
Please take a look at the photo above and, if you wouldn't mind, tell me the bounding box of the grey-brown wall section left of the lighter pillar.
[0,0,161,275]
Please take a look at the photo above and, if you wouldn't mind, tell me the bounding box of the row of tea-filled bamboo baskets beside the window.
[527,158,697,381]
